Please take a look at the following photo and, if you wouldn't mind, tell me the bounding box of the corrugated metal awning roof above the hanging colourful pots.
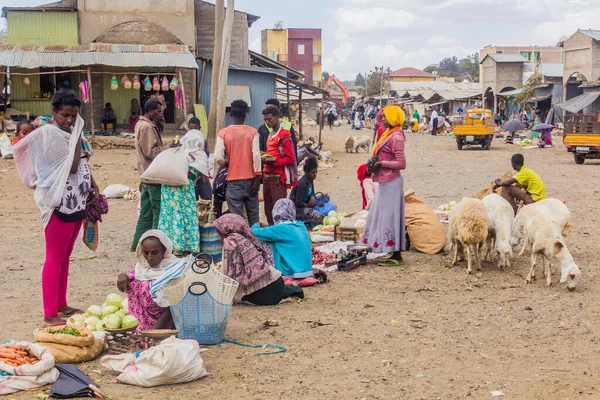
[0,43,198,69]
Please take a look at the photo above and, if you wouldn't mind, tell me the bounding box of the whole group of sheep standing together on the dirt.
[449,193,581,291]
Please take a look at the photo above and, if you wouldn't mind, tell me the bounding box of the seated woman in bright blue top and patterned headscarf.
[252,199,316,284]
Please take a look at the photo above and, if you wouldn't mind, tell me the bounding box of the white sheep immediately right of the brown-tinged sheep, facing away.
[483,193,515,268]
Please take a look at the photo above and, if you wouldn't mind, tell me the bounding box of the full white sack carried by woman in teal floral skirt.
[141,147,189,186]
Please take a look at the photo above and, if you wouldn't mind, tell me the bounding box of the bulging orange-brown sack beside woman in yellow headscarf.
[404,192,447,254]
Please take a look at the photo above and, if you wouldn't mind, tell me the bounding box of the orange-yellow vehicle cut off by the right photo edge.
[563,114,600,164]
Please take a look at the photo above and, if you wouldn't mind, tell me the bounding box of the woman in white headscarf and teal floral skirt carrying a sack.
[158,129,208,254]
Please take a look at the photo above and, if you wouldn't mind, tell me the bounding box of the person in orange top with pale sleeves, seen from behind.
[215,100,262,226]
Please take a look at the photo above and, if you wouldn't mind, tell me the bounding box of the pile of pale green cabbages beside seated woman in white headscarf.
[69,293,138,332]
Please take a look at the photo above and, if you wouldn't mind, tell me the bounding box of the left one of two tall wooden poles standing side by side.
[207,0,225,149]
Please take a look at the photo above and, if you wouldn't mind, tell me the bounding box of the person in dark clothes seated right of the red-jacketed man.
[290,157,325,226]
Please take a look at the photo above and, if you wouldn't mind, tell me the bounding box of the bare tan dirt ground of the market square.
[0,124,600,399]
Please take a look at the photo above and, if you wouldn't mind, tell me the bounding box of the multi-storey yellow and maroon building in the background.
[261,23,323,86]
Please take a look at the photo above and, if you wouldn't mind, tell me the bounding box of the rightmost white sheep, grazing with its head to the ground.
[523,207,581,291]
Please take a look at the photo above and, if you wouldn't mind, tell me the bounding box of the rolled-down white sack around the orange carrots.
[0,341,59,395]
